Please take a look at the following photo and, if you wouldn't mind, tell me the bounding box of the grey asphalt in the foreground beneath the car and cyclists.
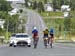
[0,43,75,56]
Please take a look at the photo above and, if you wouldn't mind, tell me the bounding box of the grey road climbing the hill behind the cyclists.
[26,11,46,38]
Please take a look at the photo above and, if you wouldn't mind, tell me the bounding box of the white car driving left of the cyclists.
[9,33,31,47]
